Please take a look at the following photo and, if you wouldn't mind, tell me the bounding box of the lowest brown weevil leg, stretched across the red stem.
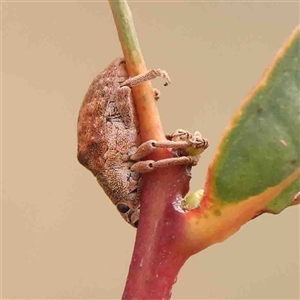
[131,156,199,173]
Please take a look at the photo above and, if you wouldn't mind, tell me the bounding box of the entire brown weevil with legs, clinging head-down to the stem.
[77,58,208,227]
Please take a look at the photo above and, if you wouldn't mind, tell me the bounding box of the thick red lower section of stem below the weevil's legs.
[122,167,190,300]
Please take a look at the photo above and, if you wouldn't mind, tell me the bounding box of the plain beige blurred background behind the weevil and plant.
[2,1,299,299]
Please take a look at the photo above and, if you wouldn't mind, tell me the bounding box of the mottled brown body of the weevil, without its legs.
[77,58,141,225]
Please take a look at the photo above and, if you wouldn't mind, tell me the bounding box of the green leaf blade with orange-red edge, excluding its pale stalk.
[210,28,300,206]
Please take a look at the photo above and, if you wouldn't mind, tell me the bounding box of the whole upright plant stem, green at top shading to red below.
[109,0,190,300]
